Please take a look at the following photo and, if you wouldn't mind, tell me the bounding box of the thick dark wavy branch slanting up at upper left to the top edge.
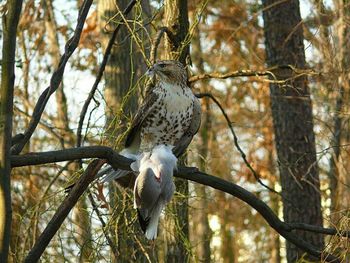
[11,0,92,154]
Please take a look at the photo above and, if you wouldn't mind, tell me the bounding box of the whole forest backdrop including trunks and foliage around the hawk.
[0,0,350,262]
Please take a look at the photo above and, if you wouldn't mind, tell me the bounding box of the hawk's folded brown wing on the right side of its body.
[173,98,202,157]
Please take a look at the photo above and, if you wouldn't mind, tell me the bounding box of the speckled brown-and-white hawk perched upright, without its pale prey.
[97,60,201,186]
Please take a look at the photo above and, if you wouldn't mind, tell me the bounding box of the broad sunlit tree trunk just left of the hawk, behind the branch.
[98,0,143,262]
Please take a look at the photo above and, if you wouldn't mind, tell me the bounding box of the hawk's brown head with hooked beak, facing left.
[147,60,187,85]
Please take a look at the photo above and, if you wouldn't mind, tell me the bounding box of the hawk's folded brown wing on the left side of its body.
[125,91,159,152]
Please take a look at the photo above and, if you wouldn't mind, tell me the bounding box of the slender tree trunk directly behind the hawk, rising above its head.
[164,0,190,262]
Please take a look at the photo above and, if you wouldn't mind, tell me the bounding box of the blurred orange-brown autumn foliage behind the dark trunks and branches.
[4,0,350,263]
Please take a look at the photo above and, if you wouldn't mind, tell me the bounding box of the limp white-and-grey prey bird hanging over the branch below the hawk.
[131,144,177,240]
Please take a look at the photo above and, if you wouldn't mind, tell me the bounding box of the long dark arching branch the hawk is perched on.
[11,146,350,262]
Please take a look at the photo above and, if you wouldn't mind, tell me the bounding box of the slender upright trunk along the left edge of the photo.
[0,0,22,263]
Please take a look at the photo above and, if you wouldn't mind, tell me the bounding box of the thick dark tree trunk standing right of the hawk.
[263,0,324,262]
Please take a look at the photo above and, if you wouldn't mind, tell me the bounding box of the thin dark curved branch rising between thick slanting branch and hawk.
[77,0,137,150]
